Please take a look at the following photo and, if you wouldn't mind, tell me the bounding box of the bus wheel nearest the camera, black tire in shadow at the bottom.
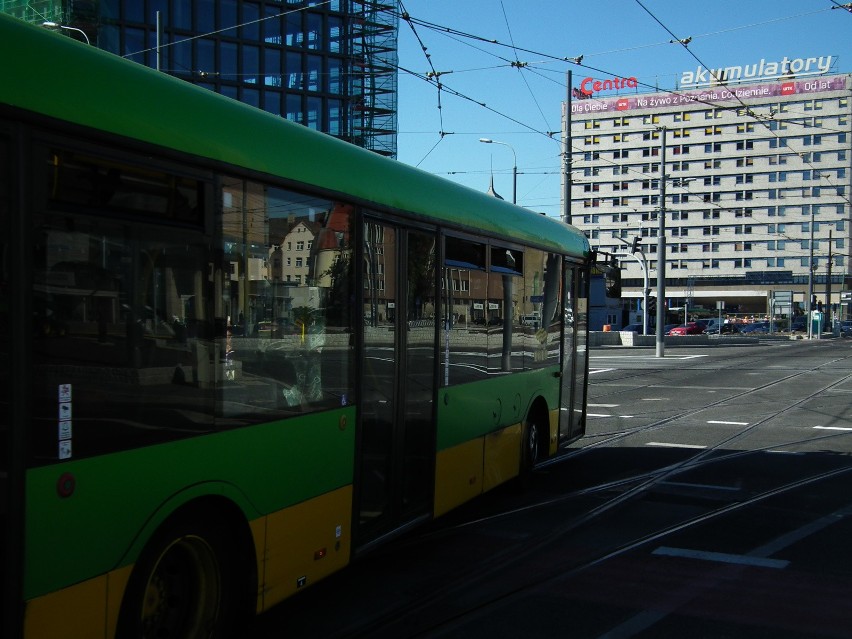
[116,513,255,639]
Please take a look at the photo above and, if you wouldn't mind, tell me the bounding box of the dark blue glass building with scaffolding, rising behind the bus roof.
[0,0,398,157]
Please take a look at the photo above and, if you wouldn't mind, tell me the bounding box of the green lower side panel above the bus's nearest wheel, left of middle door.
[24,407,355,599]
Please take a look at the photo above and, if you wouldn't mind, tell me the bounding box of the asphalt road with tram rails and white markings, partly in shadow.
[251,340,852,639]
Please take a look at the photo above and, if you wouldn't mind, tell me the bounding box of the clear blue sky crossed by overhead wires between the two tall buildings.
[398,0,852,216]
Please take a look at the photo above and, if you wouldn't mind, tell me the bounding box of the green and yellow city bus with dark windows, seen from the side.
[0,16,592,639]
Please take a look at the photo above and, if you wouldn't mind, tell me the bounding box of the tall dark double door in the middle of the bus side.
[356,220,436,546]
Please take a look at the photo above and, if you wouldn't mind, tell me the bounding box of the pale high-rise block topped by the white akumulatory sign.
[570,66,852,320]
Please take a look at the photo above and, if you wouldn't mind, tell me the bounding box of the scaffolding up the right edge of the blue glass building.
[348,0,399,157]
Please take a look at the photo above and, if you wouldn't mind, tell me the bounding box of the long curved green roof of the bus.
[0,14,590,258]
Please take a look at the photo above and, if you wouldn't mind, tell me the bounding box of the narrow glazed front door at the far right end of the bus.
[559,263,589,446]
